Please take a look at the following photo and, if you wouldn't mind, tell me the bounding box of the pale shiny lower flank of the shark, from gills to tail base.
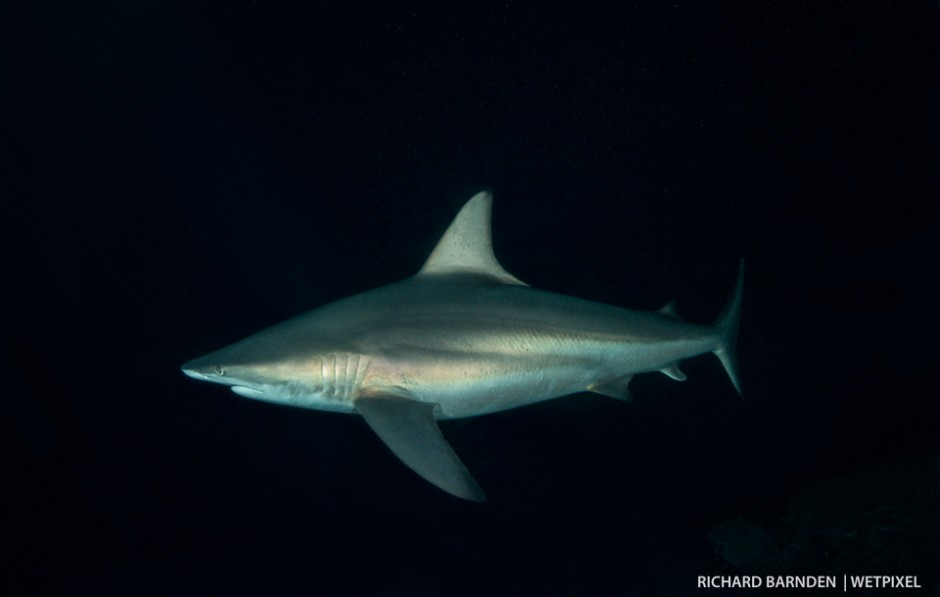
[359,326,715,419]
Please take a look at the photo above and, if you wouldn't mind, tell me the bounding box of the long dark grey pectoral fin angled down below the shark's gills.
[355,395,486,502]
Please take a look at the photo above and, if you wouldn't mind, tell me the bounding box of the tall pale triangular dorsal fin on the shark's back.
[418,191,527,286]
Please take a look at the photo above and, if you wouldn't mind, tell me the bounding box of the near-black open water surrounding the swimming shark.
[0,1,940,595]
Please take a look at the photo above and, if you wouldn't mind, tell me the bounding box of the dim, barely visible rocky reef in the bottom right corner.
[709,455,940,575]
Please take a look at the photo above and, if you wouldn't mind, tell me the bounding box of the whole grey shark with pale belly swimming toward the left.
[182,192,743,501]
